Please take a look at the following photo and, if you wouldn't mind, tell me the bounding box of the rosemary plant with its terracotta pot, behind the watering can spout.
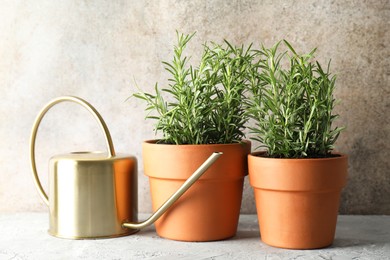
[134,33,252,241]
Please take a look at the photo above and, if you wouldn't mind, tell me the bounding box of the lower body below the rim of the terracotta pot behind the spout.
[150,178,243,242]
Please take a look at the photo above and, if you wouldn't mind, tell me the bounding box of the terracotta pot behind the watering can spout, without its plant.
[142,140,251,241]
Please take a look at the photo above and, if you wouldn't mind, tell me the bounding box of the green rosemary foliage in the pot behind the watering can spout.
[133,33,253,144]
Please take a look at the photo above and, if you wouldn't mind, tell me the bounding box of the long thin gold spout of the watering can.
[122,152,222,229]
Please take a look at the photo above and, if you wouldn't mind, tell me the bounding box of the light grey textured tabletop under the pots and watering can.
[0,213,390,260]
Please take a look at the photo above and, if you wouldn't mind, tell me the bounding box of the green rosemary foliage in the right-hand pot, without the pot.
[248,41,343,158]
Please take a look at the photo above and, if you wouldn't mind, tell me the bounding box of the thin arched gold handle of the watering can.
[30,96,115,205]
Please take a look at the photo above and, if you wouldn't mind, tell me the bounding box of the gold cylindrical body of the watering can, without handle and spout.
[49,152,138,239]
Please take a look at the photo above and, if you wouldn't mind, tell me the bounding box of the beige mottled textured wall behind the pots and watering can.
[0,0,390,214]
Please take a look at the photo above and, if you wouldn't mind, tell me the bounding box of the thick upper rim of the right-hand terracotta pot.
[248,152,348,192]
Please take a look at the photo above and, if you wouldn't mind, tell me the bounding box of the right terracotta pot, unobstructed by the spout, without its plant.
[248,153,348,249]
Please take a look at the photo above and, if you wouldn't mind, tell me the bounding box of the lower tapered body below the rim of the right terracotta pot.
[255,190,340,249]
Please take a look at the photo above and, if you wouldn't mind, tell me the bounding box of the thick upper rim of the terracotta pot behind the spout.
[142,140,251,180]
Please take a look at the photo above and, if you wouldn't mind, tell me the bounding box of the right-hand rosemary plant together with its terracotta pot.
[248,41,347,249]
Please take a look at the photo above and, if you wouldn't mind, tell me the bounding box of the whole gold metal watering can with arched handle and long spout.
[30,96,222,239]
